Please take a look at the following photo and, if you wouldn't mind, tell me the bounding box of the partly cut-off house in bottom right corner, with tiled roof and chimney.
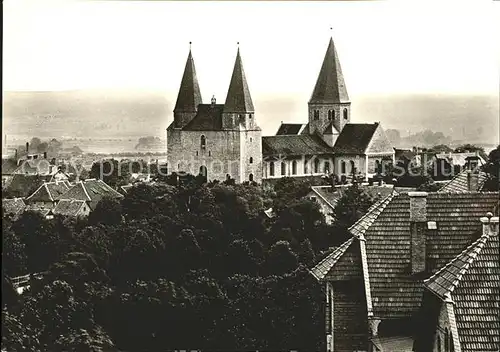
[414,213,500,352]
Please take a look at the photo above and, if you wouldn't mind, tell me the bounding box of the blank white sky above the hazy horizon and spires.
[3,0,500,102]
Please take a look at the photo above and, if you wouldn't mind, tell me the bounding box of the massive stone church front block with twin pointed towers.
[167,48,262,183]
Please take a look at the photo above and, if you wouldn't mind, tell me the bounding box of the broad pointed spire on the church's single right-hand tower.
[309,38,349,104]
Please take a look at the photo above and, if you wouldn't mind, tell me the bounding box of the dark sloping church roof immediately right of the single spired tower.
[333,123,378,154]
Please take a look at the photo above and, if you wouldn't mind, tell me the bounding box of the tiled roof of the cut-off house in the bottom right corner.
[425,217,500,352]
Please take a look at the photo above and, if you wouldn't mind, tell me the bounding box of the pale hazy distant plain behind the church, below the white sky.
[2,91,499,152]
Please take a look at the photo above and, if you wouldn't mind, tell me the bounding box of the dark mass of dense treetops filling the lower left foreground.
[2,176,359,351]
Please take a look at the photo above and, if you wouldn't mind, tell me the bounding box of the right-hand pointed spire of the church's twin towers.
[224,42,254,112]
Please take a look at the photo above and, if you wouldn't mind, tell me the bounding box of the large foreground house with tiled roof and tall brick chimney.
[311,192,500,352]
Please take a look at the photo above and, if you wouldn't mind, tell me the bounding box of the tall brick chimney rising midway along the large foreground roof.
[408,192,427,274]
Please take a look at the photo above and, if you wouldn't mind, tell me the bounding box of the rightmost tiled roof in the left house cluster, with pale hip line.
[58,179,123,209]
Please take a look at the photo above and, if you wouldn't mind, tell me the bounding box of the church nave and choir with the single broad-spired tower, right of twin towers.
[262,38,394,180]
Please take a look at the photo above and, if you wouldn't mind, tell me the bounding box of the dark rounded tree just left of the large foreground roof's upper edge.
[333,183,374,227]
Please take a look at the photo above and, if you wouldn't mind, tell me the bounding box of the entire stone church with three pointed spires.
[167,38,394,183]
